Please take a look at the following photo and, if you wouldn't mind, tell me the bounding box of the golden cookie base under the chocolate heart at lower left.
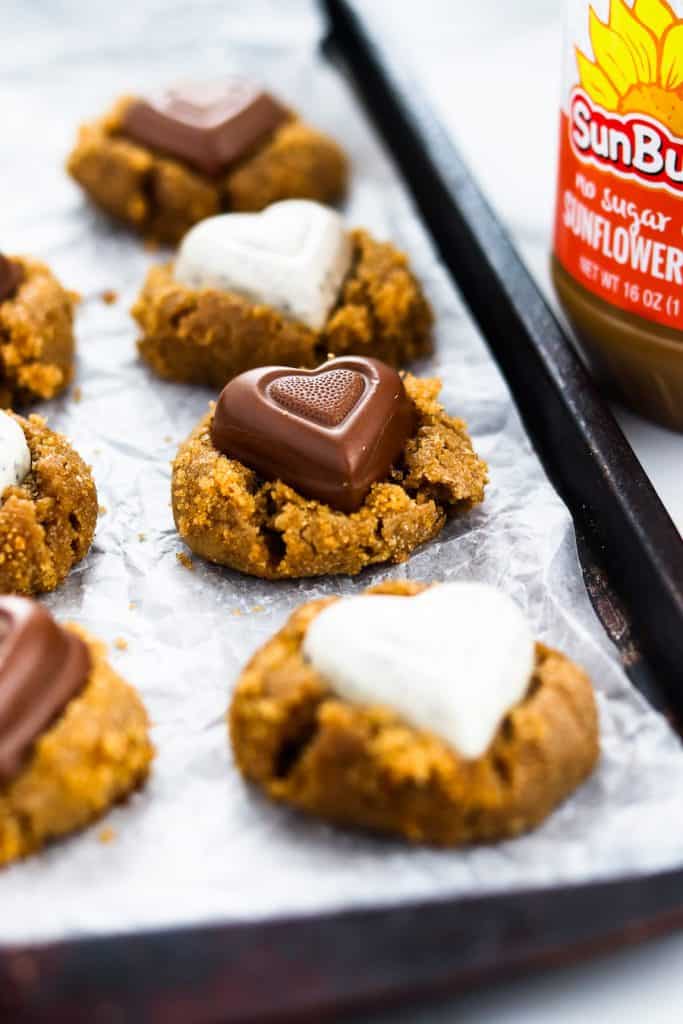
[0,627,154,866]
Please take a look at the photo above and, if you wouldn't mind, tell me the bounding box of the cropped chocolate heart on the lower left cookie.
[0,596,90,784]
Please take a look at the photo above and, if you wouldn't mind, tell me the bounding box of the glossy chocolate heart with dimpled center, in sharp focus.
[211,356,417,512]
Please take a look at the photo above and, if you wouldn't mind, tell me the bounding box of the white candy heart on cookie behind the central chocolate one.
[174,200,351,331]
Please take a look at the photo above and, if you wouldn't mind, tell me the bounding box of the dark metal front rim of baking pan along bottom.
[0,870,683,1024]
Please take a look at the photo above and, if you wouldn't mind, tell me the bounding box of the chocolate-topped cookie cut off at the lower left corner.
[0,597,154,866]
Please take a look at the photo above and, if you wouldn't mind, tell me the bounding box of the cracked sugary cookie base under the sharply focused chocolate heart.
[172,358,486,580]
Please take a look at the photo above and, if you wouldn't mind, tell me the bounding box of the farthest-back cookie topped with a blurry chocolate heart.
[67,79,348,244]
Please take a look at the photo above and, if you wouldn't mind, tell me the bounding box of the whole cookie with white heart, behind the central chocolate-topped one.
[132,201,432,388]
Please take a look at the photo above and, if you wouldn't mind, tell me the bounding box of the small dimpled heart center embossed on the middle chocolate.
[268,370,365,427]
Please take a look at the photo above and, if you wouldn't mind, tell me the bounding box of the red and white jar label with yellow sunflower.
[555,0,683,330]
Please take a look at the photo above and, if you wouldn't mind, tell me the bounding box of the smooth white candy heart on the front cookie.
[303,583,536,758]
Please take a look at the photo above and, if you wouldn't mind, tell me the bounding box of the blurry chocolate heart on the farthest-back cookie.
[123,78,289,174]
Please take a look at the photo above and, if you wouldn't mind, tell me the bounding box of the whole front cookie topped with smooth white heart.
[229,582,599,846]
